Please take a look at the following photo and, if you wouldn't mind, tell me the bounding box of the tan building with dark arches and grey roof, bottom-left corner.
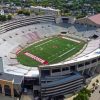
[0,73,23,100]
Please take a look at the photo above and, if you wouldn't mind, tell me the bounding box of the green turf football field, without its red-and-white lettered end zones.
[17,36,85,67]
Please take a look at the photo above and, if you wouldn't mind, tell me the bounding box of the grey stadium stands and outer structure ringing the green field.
[0,15,100,99]
